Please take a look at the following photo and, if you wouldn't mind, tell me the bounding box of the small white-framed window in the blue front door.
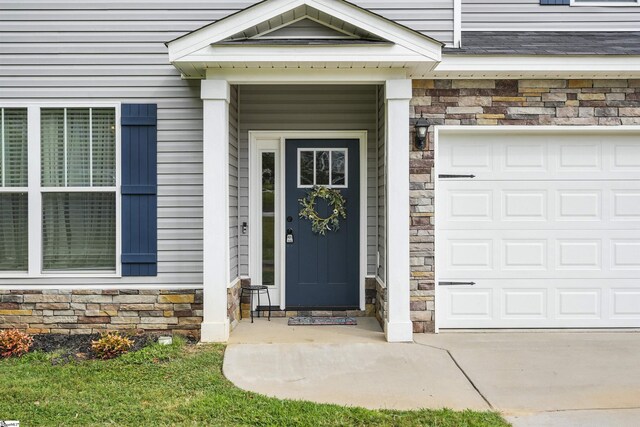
[298,148,347,188]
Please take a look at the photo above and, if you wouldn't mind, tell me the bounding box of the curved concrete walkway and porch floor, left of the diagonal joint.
[223,318,489,410]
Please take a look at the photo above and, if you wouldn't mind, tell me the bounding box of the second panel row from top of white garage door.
[436,180,640,230]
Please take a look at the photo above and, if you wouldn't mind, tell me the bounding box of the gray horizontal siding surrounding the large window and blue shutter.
[0,0,206,288]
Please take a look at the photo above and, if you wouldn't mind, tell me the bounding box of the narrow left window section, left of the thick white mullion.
[0,108,29,271]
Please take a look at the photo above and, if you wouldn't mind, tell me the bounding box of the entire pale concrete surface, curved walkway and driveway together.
[224,319,640,427]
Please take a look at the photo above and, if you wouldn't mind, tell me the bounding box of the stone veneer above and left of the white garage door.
[410,79,640,332]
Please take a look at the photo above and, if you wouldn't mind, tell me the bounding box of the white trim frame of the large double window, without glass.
[0,101,122,280]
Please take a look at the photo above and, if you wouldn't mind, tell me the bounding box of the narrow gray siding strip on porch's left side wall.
[229,86,238,281]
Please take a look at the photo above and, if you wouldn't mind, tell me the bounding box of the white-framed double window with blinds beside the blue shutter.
[0,107,119,276]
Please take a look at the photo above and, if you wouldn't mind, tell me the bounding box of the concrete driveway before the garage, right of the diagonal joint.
[415,332,640,427]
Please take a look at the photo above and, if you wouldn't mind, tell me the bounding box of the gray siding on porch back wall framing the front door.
[239,85,378,276]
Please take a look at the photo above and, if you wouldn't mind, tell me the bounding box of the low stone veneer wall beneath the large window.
[0,289,202,338]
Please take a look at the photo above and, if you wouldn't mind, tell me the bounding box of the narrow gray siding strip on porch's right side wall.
[377,86,387,282]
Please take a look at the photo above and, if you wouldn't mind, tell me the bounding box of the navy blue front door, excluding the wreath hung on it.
[285,139,360,310]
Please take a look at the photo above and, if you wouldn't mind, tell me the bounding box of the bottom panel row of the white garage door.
[437,278,640,328]
